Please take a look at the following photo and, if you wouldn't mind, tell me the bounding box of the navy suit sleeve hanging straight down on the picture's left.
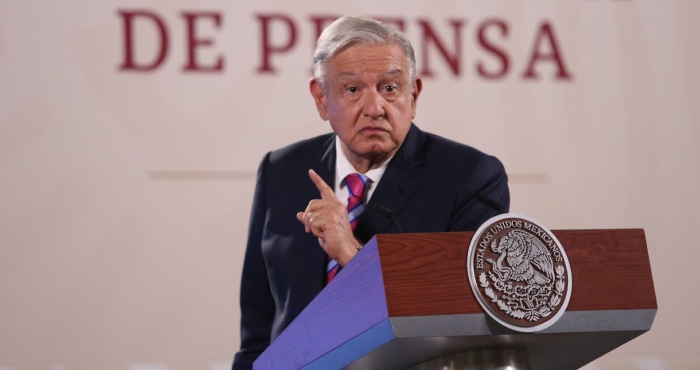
[232,153,275,370]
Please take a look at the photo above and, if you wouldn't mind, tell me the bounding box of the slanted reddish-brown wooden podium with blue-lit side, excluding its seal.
[254,229,657,370]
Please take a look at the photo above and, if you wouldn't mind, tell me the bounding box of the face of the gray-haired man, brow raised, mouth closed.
[311,45,421,170]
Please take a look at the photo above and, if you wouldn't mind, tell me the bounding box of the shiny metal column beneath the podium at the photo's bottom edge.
[407,349,530,370]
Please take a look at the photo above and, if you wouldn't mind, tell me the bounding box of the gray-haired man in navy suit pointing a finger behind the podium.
[233,17,509,370]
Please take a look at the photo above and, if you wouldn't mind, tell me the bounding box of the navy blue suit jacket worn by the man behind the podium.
[233,125,510,370]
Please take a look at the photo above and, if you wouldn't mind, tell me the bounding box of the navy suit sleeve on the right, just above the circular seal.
[449,156,510,231]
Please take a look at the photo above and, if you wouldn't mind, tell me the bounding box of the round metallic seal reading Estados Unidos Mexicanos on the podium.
[467,213,571,332]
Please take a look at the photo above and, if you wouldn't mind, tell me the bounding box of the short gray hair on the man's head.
[314,16,416,90]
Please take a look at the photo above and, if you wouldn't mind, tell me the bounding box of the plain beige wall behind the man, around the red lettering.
[0,0,700,370]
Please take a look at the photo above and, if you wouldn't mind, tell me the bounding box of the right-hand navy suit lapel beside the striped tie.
[356,125,425,243]
